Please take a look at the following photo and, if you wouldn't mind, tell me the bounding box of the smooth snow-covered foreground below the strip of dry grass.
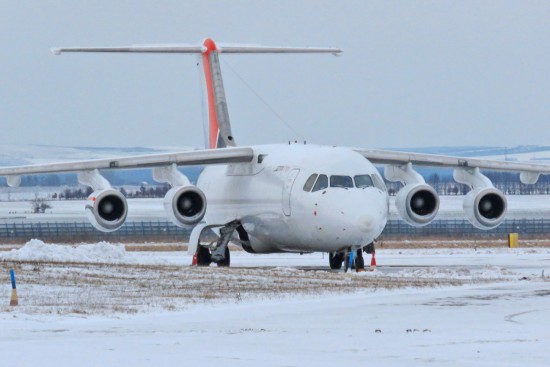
[0,282,550,367]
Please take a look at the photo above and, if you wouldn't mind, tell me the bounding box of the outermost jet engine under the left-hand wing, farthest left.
[85,189,128,232]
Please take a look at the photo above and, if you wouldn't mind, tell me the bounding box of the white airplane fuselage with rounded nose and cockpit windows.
[197,144,388,253]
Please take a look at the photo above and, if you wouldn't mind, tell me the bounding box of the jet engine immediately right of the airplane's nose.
[395,184,439,227]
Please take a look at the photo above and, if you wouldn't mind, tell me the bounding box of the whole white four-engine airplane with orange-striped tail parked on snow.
[0,39,550,270]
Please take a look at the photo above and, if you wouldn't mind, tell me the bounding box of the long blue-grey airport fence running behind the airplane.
[0,219,550,242]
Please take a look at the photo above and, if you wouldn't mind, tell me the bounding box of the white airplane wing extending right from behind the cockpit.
[356,149,550,178]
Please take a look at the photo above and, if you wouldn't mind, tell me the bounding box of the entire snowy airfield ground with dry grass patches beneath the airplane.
[0,241,550,367]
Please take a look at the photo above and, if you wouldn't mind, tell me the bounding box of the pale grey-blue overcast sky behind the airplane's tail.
[0,0,550,147]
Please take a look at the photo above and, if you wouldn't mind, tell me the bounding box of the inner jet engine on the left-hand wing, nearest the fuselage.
[164,186,206,227]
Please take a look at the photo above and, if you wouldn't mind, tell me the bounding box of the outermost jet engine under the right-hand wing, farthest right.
[462,187,508,229]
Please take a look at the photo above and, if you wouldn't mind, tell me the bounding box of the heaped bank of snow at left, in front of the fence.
[1,240,126,263]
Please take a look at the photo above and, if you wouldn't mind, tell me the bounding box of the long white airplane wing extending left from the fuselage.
[0,147,254,178]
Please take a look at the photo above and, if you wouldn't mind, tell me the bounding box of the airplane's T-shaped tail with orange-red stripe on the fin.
[52,38,342,149]
